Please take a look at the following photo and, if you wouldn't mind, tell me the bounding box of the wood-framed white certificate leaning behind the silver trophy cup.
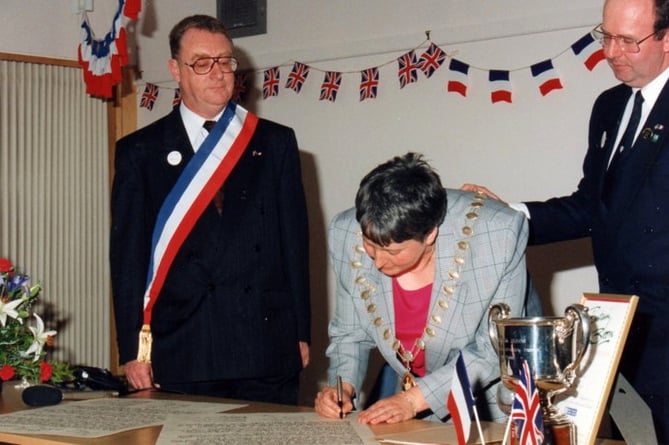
[557,293,639,445]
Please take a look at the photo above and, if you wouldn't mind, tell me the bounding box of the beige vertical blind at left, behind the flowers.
[0,60,110,367]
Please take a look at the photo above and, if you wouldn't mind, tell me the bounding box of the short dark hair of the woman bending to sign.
[355,153,447,246]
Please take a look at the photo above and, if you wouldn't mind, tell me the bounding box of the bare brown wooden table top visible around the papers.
[0,384,624,445]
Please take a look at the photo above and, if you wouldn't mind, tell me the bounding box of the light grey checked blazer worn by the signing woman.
[326,189,528,420]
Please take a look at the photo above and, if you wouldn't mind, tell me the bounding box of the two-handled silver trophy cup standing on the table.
[488,303,591,434]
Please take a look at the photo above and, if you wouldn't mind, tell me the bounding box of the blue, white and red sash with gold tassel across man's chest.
[137,102,258,363]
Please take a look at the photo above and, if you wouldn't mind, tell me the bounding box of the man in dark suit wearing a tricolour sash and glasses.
[110,15,310,404]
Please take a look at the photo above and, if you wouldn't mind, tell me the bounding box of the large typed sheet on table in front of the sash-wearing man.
[0,398,246,438]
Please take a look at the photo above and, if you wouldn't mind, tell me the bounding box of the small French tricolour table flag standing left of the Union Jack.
[446,351,474,445]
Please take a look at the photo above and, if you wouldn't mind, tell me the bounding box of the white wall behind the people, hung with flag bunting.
[0,0,615,397]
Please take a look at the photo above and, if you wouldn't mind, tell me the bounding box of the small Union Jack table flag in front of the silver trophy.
[511,360,544,445]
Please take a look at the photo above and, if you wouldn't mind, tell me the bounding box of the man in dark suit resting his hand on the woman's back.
[463,0,669,443]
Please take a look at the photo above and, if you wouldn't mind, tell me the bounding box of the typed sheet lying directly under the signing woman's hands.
[156,412,378,445]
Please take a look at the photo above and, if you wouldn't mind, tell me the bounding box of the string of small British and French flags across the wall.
[133,31,604,110]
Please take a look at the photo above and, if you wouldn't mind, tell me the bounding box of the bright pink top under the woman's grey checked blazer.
[393,278,432,377]
